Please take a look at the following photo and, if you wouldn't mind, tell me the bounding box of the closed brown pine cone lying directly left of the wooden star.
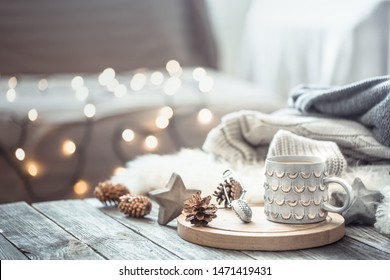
[118,194,152,218]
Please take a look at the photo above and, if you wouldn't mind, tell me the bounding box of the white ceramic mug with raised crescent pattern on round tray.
[264,156,352,224]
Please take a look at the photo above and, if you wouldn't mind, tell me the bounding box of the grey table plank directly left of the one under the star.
[33,200,178,259]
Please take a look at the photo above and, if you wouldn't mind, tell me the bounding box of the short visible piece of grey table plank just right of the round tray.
[346,226,390,253]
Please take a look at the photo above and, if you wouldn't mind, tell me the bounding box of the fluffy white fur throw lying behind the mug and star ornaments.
[111,149,390,234]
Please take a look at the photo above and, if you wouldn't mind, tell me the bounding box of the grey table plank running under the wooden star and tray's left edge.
[86,199,251,259]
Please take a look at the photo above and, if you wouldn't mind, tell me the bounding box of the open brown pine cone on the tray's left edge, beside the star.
[183,192,217,226]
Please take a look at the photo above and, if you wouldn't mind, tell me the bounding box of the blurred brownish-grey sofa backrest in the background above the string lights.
[0,0,217,74]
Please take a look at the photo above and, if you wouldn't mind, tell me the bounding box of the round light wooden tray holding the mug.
[177,206,345,251]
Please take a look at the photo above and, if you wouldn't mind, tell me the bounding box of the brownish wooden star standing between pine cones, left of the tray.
[149,173,199,225]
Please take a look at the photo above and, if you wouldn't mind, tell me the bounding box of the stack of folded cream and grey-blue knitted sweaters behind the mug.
[203,76,390,168]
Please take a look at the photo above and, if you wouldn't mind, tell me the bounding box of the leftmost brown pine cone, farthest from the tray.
[93,181,130,205]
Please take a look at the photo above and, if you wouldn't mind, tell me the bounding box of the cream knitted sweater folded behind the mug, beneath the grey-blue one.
[203,109,390,175]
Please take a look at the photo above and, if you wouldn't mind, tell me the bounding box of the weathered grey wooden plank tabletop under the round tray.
[0,198,390,260]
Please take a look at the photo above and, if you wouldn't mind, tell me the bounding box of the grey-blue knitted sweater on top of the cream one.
[289,76,390,147]
